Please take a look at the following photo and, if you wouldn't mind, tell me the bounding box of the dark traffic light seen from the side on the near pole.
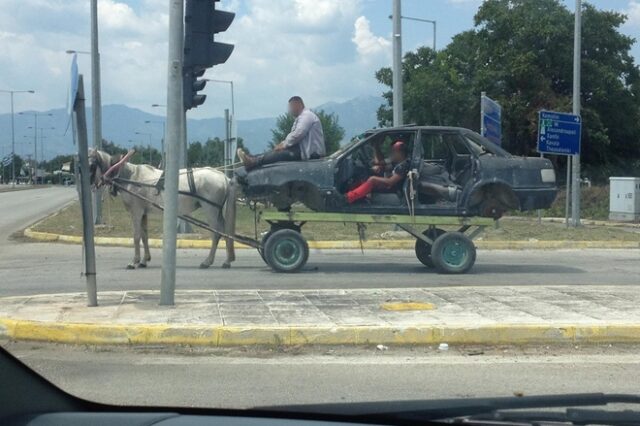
[182,0,235,110]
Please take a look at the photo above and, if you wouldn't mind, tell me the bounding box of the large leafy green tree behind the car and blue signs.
[376,0,640,179]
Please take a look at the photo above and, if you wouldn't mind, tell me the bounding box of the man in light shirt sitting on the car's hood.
[237,96,326,170]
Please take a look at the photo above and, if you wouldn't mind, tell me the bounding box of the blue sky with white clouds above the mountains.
[0,0,640,119]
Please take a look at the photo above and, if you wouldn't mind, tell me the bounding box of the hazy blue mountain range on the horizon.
[0,96,384,159]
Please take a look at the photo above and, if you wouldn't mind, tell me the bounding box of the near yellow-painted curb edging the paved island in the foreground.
[0,318,640,346]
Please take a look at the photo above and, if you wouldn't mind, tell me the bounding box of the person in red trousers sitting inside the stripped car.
[345,141,411,204]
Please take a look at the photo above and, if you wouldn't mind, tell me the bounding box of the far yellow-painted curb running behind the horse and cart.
[24,228,640,250]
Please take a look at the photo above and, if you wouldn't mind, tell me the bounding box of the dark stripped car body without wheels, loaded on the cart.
[236,126,557,218]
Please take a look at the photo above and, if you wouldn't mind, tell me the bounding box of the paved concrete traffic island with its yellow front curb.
[0,286,640,346]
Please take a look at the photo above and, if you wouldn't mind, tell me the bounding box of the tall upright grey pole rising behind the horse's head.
[91,0,103,225]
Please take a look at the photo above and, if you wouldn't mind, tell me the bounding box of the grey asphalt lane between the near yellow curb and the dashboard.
[5,342,640,407]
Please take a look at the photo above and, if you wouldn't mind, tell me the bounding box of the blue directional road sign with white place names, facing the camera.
[538,111,582,155]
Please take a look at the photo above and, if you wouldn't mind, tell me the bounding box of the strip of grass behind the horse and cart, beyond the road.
[34,197,640,241]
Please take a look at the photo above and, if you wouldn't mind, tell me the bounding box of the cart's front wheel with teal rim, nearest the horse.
[264,229,309,272]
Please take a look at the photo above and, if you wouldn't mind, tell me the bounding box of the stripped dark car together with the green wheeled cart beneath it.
[236,126,557,273]
